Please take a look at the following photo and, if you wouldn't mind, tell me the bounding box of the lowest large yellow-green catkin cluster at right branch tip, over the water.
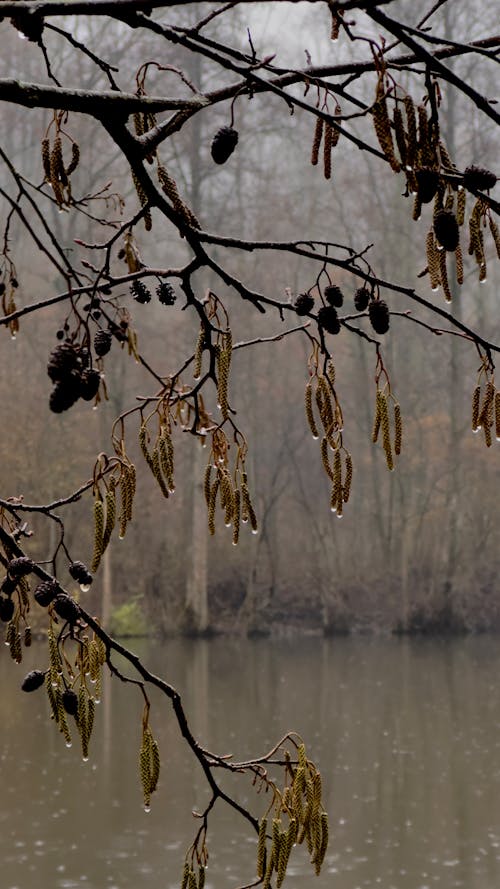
[257,744,328,889]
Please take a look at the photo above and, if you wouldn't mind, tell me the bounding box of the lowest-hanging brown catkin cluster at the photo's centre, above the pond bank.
[203,448,258,546]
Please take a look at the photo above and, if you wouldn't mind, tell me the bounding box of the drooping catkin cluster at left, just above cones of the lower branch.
[90,459,136,573]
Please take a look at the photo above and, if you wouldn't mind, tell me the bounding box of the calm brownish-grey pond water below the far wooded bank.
[0,638,500,889]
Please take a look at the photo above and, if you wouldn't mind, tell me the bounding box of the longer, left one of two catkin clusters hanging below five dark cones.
[305,361,352,518]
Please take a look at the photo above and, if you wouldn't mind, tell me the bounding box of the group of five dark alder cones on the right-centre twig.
[294,284,389,334]
